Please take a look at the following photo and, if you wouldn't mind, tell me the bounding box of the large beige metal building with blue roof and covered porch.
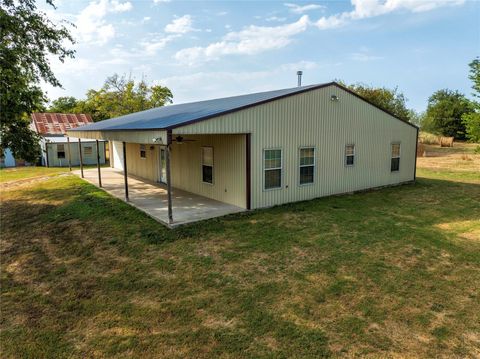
[67,82,418,224]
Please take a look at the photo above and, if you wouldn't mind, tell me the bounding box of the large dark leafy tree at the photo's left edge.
[0,0,74,162]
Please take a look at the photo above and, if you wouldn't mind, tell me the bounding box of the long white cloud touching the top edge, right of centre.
[315,0,465,29]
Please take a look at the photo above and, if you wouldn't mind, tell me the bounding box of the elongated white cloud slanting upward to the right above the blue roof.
[175,15,309,65]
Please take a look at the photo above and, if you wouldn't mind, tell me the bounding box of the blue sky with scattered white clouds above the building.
[38,0,480,111]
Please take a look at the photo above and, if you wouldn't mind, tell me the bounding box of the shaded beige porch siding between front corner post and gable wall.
[171,135,246,208]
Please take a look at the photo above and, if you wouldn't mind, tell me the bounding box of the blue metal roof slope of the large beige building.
[69,83,332,132]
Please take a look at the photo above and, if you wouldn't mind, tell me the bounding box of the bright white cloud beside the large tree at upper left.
[74,0,132,45]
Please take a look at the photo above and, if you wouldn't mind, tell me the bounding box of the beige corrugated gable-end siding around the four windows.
[174,86,416,208]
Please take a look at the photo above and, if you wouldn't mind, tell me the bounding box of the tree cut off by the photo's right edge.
[462,57,480,144]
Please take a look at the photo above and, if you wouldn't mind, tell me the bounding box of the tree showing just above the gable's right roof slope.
[347,84,412,122]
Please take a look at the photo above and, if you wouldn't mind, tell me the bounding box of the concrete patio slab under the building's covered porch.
[73,167,245,227]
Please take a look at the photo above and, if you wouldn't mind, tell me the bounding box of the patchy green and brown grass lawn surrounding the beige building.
[0,148,480,358]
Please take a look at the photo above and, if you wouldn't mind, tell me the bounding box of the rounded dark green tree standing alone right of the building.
[423,89,473,140]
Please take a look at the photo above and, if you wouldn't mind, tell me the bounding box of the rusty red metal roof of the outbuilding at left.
[32,112,93,135]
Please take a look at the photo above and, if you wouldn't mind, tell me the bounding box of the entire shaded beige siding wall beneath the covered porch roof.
[116,135,246,208]
